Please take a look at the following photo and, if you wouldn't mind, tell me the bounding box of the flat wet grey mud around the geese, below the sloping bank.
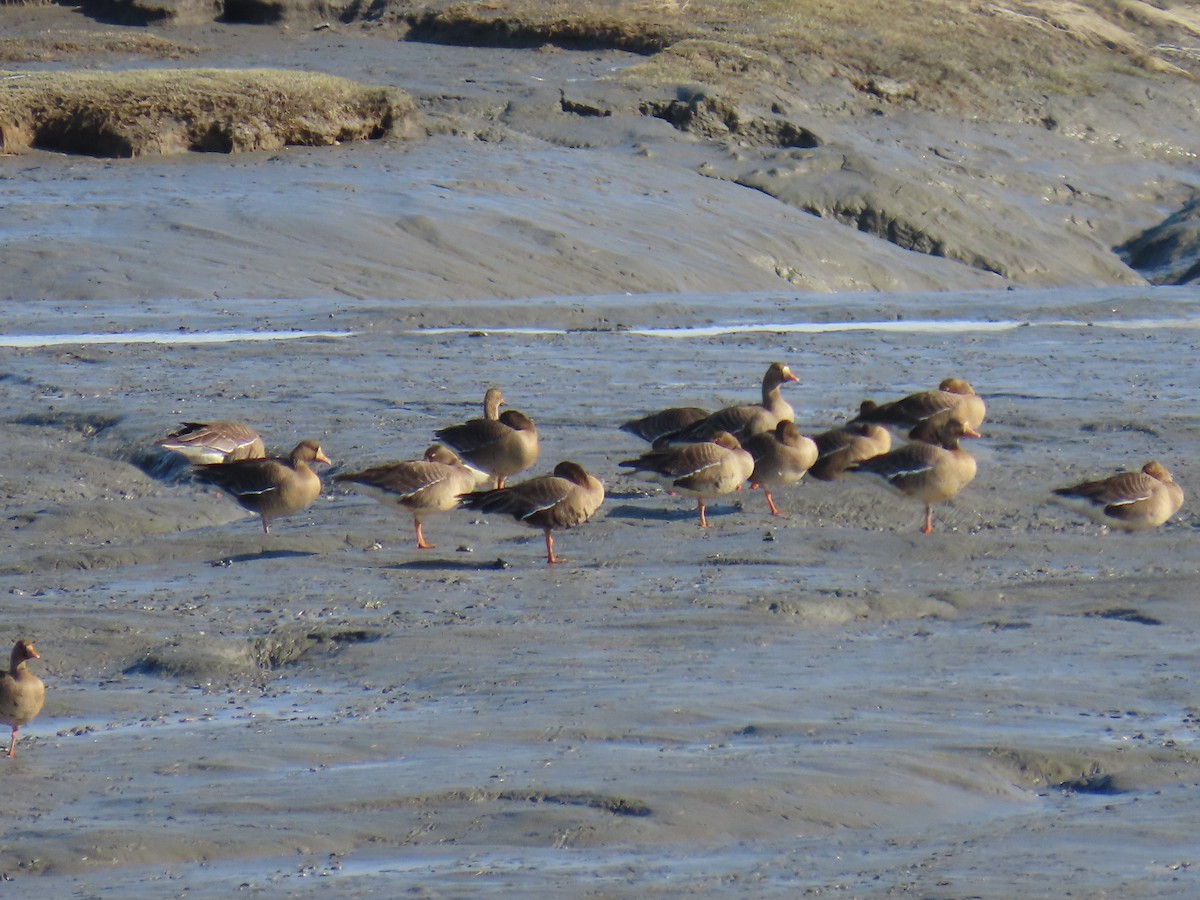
[0,280,1200,898]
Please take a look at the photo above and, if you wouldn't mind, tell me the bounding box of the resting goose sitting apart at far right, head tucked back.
[1055,460,1183,532]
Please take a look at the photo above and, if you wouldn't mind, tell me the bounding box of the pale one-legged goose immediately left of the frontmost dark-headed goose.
[334,444,475,550]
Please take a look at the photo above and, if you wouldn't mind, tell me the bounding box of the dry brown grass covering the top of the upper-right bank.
[376,0,1200,110]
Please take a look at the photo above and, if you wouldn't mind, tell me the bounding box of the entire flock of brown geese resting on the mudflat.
[0,362,1183,757]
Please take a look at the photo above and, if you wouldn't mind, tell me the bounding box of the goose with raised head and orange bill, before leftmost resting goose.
[193,440,330,534]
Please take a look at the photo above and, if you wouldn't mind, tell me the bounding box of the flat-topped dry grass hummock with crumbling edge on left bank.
[0,70,413,156]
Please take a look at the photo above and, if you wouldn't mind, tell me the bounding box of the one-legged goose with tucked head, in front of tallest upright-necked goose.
[618,431,754,528]
